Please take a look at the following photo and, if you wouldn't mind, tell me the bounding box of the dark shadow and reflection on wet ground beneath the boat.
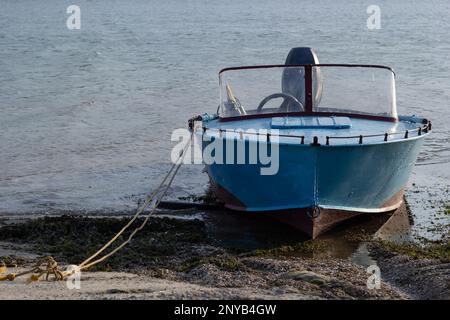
[197,200,411,264]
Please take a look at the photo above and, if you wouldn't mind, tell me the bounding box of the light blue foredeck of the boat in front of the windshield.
[200,116,426,145]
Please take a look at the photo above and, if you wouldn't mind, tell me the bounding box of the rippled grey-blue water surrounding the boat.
[0,0,450,240]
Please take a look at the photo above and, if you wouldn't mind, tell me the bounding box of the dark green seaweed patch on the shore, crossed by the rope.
[0,215,211,271]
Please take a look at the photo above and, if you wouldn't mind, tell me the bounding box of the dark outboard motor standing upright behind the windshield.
[281,47,322,111]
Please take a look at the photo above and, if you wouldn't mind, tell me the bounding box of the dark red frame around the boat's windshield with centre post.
[217,63,398,122]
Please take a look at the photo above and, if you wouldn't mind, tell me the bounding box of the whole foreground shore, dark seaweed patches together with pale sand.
[0,216,450,299]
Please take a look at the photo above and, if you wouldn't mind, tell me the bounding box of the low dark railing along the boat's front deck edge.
[202,119,431,146]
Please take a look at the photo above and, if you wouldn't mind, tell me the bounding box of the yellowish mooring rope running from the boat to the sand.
[0,132,194,282]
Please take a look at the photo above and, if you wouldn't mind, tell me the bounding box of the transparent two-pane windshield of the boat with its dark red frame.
[218,64,397,119]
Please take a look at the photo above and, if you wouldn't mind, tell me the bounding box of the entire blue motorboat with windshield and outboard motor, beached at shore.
[190,48,431,238]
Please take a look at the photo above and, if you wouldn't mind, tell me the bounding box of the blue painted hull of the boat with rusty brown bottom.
[203,136,423,238]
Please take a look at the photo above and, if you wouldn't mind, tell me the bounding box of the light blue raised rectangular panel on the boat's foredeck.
[270,116,352,129]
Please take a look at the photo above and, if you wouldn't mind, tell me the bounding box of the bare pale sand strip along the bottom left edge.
[0,272,318,300]
